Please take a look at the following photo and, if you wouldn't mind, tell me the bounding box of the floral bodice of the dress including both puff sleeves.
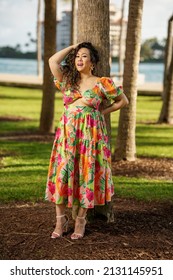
[54,77,123,109]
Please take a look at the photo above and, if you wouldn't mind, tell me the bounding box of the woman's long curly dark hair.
[62,42,99,89]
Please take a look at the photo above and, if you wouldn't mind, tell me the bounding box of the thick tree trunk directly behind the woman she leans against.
[78,0,114,222]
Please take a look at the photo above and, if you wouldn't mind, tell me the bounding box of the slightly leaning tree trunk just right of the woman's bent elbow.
[114,0,144,161]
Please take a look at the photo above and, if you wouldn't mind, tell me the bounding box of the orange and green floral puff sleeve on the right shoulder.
[100,77,123,100]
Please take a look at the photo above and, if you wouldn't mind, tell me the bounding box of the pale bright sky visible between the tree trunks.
[0,0,173,50]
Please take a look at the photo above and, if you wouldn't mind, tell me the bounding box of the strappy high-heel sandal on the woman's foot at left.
[51,215,69,238]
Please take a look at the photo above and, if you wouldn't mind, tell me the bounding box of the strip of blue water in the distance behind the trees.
[0,58,164,82]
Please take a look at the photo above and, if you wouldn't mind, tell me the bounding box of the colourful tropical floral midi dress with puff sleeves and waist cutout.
[46,77,123,208]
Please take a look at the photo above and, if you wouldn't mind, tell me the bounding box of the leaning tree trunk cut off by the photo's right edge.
[158,15,173,124]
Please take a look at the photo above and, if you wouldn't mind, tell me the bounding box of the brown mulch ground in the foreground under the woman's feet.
[0,197,173,260]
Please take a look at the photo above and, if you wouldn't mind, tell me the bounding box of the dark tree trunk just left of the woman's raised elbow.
[40,0,56,133]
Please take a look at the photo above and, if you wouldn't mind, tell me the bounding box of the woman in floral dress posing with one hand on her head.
[46,42,128,239]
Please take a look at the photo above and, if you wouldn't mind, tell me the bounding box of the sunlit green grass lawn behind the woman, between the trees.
[0,87,173,203]
